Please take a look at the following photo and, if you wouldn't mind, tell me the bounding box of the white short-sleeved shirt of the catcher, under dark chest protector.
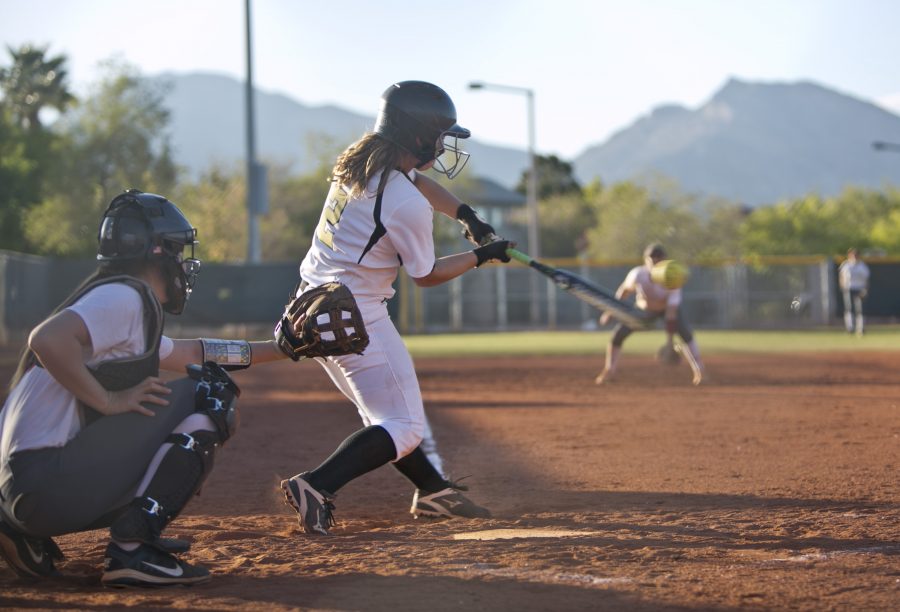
[0,283,173,468]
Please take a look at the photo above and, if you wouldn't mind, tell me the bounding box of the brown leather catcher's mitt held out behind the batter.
[275,282,369,361]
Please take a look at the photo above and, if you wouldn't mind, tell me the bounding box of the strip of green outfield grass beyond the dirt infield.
[404,326,900,357]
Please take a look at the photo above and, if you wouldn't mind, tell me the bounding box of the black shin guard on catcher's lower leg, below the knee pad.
[110,431,220,543]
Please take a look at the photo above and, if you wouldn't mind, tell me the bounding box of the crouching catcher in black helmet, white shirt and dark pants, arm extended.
[0,190,362,587]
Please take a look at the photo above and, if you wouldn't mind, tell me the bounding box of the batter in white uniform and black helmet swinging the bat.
[281,81,510,535]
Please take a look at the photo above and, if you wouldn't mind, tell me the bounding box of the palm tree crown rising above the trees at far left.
[0,44,75,130]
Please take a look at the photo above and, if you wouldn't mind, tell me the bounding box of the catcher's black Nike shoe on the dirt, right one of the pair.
[100,542,209,588]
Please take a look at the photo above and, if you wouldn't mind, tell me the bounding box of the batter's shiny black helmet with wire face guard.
[374,81,471,178]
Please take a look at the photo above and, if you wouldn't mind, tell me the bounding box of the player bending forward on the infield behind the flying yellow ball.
[594,244,703,385]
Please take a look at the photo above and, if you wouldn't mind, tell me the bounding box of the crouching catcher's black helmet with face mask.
[97,189,200,314]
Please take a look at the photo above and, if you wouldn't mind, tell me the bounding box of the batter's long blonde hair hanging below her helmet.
[331,133,405,198]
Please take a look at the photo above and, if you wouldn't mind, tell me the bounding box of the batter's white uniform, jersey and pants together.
[300,170,435,459]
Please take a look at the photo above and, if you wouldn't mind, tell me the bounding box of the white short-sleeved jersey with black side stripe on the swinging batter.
[300,170,435,315]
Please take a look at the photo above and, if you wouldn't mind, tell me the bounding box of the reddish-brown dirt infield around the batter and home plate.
[0,353,900,610]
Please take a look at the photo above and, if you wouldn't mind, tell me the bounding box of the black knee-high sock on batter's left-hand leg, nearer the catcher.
[305,425,397,494]
